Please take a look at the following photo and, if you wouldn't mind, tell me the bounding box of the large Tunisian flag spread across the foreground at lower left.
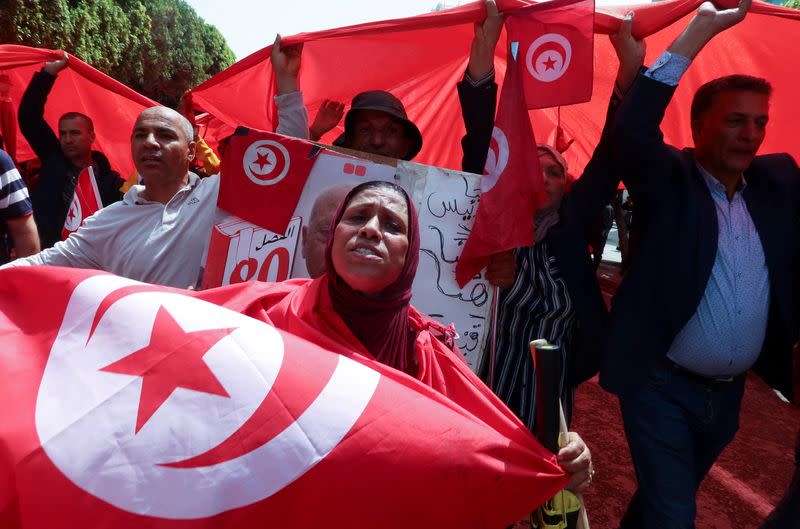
[0,267,567,529]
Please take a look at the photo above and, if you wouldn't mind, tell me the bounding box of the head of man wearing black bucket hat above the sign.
[333,90,422,160]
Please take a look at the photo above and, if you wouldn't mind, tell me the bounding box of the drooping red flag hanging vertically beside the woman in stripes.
[456,53,546,287]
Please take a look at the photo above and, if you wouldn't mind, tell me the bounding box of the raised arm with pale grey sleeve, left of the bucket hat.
[272,35,309,139]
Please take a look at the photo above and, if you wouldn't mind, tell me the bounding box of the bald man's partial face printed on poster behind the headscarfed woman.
[301,184,353,279]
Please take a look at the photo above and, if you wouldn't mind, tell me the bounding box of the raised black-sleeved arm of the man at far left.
[17,53,69,159]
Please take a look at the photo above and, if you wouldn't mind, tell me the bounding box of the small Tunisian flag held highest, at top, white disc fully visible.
[506,0,594,108]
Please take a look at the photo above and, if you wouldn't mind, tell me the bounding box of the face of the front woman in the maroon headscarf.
[331,188,408,295]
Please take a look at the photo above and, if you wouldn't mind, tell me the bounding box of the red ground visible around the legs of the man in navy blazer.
[571,263,800,529]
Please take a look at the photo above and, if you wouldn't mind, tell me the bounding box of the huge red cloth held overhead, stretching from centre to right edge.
[184,0,800,174]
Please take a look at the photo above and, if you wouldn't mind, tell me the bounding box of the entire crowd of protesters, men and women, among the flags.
[0,0,800,528]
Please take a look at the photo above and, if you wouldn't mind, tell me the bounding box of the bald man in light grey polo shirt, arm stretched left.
[6,107,219,288]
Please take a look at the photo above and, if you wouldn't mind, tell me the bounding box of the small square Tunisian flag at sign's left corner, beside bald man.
[217,129,319,233]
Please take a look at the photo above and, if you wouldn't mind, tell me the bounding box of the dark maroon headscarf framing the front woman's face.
[325,182,419,376]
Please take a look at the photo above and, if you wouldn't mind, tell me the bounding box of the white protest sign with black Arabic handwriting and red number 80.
[201,138,492,367]
